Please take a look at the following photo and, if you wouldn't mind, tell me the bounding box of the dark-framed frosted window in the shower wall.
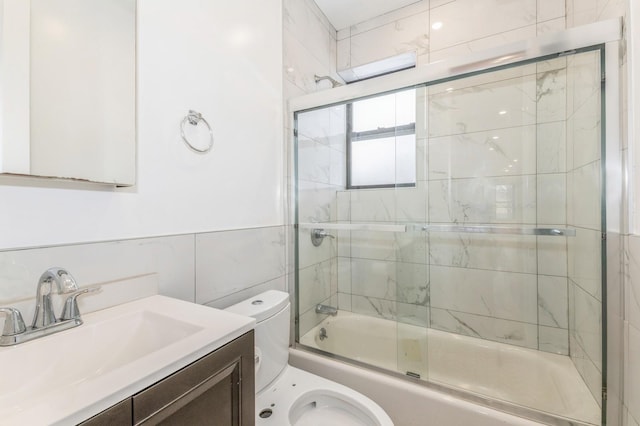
[347,89,416,189]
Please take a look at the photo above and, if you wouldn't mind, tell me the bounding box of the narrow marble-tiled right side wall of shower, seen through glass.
[567,52,603,401]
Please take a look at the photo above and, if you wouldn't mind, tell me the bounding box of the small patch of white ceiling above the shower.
[315,0,417,30]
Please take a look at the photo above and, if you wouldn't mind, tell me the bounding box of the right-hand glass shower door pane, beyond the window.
[426,50,603,424]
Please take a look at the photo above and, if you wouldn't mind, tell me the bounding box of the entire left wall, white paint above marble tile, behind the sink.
[0,0,286,321]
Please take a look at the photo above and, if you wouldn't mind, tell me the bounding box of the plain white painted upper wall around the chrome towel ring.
[0,0,284,249]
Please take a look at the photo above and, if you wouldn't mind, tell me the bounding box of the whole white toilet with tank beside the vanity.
[226,290,393,426]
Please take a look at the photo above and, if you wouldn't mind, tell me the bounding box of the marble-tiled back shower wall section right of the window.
[429,60,568,354]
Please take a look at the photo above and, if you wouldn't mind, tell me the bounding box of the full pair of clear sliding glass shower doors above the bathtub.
[295,49,605,424]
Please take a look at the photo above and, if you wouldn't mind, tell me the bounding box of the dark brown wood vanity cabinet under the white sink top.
[81,331,255,426]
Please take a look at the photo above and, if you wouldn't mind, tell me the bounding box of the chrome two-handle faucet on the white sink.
[0,268,100,346]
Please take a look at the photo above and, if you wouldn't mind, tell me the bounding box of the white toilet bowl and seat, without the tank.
[256,366,393,426]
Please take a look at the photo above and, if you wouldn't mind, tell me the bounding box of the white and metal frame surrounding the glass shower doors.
[287,19,626,425]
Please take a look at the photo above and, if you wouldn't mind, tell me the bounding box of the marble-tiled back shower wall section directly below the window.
[338,182,429,326]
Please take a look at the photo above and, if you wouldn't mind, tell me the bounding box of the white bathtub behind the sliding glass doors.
[291,311,600,426]
